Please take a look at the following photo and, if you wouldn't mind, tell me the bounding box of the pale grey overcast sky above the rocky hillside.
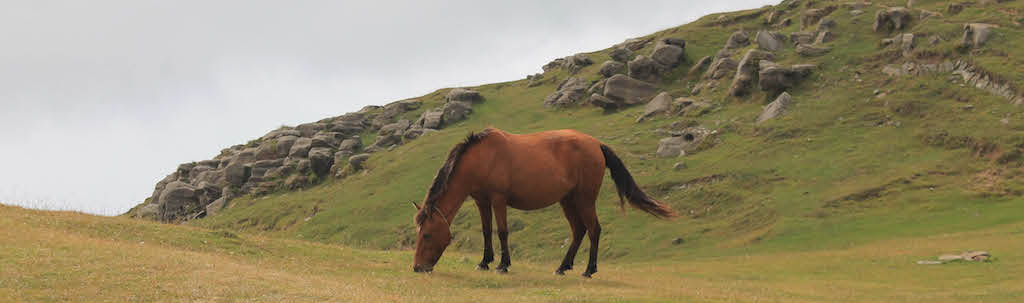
[0,0,777,214]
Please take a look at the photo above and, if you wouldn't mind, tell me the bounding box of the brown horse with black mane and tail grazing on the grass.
[413,128,676,277]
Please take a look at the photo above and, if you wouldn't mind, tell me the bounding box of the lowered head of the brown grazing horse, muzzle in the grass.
[413,203,452,272]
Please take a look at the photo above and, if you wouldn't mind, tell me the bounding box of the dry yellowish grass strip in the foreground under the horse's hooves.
[0,207,1024,302]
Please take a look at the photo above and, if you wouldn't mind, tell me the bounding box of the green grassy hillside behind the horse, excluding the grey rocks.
[132,1,1024,278]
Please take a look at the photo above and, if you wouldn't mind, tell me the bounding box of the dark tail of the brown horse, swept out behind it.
[601,144,678,219]
